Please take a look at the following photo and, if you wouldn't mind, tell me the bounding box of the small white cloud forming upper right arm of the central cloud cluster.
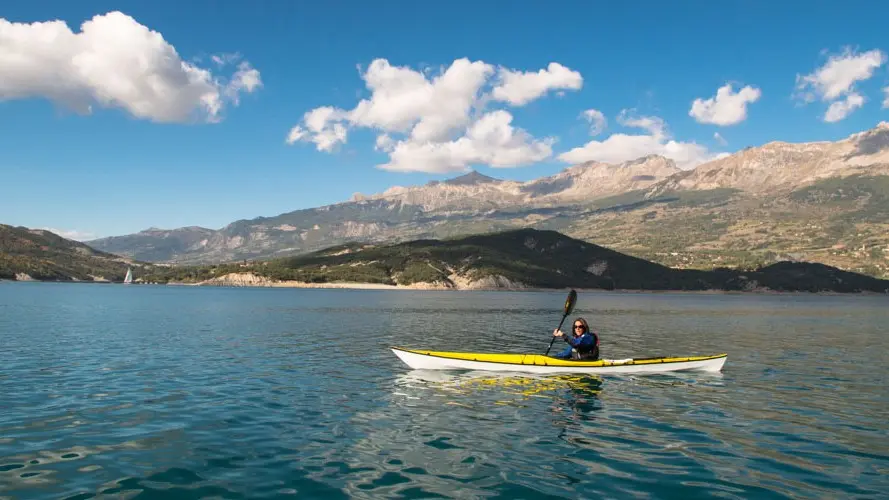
[491,62,583,106]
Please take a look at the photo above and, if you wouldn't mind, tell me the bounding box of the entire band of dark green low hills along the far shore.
[0,225,889,294]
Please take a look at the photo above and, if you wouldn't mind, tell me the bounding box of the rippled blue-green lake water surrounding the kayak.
[0,282,889,499]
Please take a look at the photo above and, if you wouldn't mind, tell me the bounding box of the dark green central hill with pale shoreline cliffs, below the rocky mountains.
[137,229,889,293]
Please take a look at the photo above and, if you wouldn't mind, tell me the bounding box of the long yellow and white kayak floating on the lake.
[391,347,728,373]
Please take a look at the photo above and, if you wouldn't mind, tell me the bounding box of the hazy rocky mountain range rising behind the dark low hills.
[86,122,889,277]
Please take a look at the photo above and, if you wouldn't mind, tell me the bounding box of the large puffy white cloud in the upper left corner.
[0,11,262,122]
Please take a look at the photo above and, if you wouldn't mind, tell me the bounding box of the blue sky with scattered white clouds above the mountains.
[0,0,889,240]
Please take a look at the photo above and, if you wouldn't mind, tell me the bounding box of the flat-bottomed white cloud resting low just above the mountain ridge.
[558,110,723,169]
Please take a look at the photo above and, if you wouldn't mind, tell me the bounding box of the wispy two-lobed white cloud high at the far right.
[793,48,886,122]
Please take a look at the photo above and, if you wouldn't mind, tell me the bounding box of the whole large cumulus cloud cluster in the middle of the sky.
[285,58,582,173]
